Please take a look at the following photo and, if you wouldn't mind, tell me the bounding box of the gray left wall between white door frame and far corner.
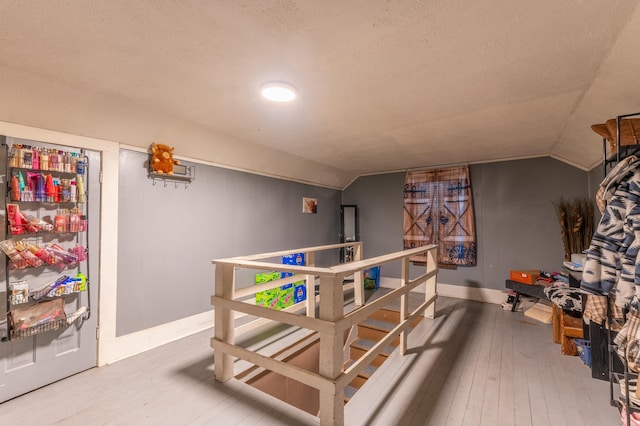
[114,150,341,336]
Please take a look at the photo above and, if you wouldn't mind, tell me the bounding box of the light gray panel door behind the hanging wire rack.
[0,137,101,402]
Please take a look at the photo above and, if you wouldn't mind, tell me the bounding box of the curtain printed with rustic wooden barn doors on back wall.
[404,166,476,268]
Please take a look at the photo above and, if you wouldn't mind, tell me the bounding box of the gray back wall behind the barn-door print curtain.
[342,158,599,289]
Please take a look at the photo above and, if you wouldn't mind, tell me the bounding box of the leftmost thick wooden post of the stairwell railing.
[213,263,235,382]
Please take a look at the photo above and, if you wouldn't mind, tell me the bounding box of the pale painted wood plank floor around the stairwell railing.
[0,298,620,426]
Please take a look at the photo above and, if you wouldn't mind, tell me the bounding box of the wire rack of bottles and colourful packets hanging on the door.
[0,136,91,340]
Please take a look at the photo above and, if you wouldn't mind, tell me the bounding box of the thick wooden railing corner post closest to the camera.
[319,276,344,426]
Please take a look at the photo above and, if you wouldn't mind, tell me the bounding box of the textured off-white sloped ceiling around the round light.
[0,0,640,188]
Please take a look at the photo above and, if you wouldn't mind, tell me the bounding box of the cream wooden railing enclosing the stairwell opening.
[211,242,438,425]
